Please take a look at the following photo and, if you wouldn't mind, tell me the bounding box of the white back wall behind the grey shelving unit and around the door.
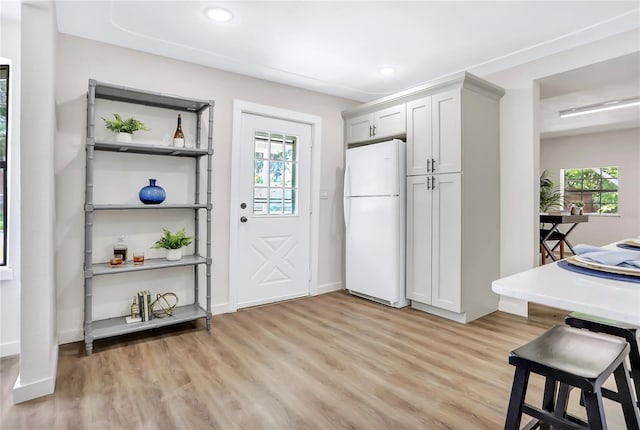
[55,35,357,343]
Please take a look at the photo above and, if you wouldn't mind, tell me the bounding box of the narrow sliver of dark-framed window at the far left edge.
[0,64,9,266]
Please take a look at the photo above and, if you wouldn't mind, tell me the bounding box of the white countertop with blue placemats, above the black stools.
[491,254,640,326]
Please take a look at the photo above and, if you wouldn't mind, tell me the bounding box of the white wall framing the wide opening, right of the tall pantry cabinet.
[483,29,640,315]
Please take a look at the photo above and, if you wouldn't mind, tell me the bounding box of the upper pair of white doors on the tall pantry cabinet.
[407,89,462,176]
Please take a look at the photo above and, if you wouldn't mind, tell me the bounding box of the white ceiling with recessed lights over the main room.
[55,0,640,101]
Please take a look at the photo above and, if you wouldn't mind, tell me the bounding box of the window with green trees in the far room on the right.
[562,167,618,214]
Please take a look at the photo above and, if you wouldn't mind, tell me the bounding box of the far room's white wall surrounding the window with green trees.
[540,128,640,245]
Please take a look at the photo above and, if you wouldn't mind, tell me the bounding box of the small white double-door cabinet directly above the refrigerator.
[345,103,407,144]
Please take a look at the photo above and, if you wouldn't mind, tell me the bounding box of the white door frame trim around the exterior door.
[228,99,322,312]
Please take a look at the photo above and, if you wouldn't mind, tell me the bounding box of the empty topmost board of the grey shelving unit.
[96,82,213,112]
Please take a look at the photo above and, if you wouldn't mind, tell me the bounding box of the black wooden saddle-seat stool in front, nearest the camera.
[504,326,640,430]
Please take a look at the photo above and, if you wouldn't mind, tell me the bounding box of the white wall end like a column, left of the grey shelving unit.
[13,2,58,403]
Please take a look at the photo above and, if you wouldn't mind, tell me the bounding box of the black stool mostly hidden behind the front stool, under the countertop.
[564,312,640,407]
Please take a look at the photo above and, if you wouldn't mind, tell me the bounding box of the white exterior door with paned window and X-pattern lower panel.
[229,112,312,308]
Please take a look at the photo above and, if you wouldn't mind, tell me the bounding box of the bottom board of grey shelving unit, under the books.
[91,303,207,339]
